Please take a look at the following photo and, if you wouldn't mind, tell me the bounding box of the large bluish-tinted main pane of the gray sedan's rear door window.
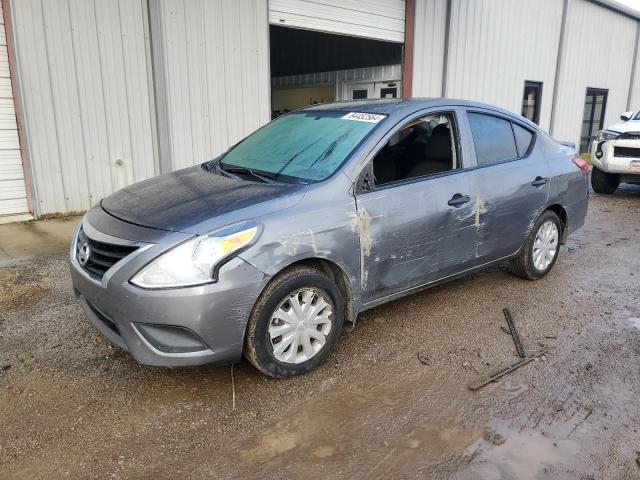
[468,112,518,165]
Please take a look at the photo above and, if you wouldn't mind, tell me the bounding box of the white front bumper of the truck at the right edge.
[590,139,640,175]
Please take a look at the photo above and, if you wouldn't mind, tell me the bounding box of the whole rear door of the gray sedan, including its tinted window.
[467,109,551,265]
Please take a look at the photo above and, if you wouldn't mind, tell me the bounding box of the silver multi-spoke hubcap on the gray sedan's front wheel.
[269,288,333,363]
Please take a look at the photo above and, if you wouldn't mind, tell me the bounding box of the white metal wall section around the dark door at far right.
[553,0,638,145]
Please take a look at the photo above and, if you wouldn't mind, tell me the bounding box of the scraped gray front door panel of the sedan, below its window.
[356,171,478,300]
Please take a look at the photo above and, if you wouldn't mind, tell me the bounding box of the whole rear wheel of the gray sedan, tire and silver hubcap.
[510,210,562,280]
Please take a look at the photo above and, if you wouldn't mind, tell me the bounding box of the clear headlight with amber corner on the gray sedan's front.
[131,226,258,288]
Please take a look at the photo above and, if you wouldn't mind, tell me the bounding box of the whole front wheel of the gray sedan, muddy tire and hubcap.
[244,266,345,378]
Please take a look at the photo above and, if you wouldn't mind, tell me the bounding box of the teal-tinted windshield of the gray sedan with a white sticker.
[221,111,385,181]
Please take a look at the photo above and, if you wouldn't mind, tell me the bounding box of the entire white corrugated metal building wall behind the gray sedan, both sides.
[5,0,640,218]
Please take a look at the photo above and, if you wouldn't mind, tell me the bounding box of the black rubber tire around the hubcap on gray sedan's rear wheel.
[510,210,563,280]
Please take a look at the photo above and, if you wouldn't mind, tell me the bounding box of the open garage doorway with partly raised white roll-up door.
[269,0,406,118]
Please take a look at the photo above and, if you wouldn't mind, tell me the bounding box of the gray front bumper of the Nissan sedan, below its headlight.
[71,209,268,367]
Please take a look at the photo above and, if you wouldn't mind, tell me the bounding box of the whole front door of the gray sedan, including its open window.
[356,112,477,302]
